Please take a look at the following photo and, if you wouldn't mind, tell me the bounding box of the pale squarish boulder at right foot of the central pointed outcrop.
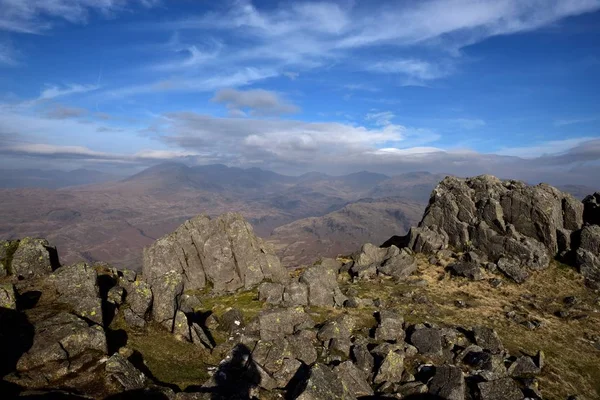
[300,265,347,307]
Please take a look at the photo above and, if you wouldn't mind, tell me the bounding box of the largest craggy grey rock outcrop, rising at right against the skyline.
[409,175,583,282]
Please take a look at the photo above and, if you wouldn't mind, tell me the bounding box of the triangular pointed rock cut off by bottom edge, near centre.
[295,363,356,400]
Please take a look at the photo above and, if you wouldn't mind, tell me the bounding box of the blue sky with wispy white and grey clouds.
[0,0,600,184]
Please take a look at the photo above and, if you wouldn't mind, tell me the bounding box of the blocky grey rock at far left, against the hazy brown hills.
[7,238,58,278]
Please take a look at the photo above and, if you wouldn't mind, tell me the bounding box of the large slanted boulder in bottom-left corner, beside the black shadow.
[10,312,107,388]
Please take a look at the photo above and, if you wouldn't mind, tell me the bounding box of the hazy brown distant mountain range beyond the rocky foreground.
[0,163,593,268]
